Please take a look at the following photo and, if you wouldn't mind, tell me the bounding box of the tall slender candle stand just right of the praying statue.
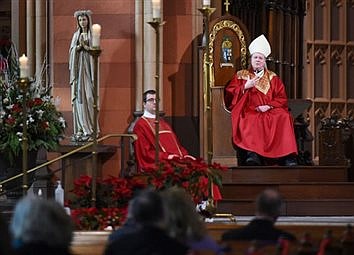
[88,46,102,207]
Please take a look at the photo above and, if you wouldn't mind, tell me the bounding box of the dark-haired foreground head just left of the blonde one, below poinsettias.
[129,190,164,226]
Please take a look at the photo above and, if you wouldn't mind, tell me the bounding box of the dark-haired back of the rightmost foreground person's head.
[256,189,282,218]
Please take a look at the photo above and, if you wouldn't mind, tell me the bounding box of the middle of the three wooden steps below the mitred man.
[221,182,354,200]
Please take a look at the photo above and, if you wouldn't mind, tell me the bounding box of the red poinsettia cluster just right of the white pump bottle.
[68,175,146,230]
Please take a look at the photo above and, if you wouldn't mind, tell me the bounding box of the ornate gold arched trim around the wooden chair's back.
[207,20,247,87]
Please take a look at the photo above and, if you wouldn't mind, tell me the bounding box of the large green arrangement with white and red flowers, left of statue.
[0,40,66,165]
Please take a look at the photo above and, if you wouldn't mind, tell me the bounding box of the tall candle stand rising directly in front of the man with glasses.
[148,18,166,166]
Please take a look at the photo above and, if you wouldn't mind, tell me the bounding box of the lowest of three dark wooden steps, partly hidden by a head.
[217,199,354,216]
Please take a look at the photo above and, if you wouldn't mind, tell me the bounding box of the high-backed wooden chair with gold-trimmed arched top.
[200,14,250,166]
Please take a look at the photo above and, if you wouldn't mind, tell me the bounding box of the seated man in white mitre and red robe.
[225,35,297,166]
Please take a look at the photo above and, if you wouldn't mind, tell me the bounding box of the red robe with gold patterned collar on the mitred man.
[225,70,297,158]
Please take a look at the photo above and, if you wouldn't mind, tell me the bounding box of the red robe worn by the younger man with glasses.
[133,116,221,201]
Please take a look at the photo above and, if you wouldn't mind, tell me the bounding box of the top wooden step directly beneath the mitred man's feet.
[222,166,348,183]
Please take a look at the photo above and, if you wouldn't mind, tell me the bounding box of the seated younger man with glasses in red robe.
[133,90,221,201]
